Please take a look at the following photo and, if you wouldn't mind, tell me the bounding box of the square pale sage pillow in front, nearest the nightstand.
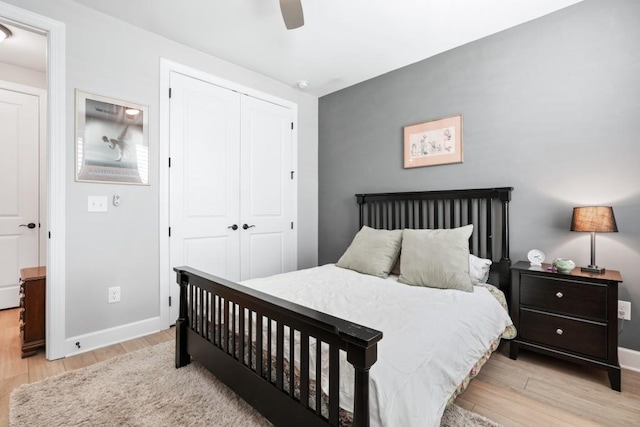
[398,225,473,292]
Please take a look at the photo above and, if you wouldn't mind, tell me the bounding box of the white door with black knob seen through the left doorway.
[0,88,40,309]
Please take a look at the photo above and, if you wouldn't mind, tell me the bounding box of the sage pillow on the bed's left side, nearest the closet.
[336,225,402,278]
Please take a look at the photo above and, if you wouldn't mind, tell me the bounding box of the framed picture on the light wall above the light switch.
[76,90,149,185]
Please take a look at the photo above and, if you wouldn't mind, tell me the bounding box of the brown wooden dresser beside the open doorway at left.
[20,267,47,357]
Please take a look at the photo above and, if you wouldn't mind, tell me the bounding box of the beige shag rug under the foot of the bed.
[9,341,498,427]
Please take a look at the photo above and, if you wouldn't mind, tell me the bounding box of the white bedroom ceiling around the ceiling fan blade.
[0,0,582,96]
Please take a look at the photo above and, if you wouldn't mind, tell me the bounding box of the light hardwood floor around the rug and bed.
[0,309,640,427]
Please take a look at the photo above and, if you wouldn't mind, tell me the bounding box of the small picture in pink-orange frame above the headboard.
[404,115,462,168]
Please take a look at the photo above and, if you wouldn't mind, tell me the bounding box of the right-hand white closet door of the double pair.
[240,96,297,280]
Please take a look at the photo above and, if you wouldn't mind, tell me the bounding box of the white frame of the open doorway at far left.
[0,2,67,360]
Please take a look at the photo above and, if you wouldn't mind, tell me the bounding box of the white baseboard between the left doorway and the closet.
[64,317,166,357]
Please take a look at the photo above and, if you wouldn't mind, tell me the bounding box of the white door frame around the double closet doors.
[158,57,299,327]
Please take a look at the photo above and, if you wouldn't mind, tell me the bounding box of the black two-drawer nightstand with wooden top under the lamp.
[509,261,622,391]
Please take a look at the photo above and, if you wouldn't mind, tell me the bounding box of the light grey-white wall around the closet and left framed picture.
[2,0,318,351]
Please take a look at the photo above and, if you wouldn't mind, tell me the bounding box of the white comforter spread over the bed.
[238,264,512,426]
